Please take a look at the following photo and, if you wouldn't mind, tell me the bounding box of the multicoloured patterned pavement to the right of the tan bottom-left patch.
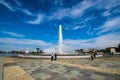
[14,55,120,80]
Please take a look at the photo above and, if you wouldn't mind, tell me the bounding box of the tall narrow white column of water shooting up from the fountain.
[58,25,63,54]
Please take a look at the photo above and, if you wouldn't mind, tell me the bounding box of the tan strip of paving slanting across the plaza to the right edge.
[44,60,120,74]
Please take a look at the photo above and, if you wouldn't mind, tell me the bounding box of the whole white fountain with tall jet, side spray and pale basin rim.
[18,25,102,59]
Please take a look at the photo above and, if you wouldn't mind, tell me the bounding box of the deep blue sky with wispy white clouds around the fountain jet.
[0,0,120,51]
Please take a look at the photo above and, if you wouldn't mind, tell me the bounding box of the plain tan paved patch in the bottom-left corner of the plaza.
[3,58,34,80]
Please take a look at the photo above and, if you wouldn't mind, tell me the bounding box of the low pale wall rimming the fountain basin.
[18,55,103,59]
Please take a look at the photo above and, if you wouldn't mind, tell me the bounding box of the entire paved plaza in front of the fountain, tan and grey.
[1,56,120,80]
